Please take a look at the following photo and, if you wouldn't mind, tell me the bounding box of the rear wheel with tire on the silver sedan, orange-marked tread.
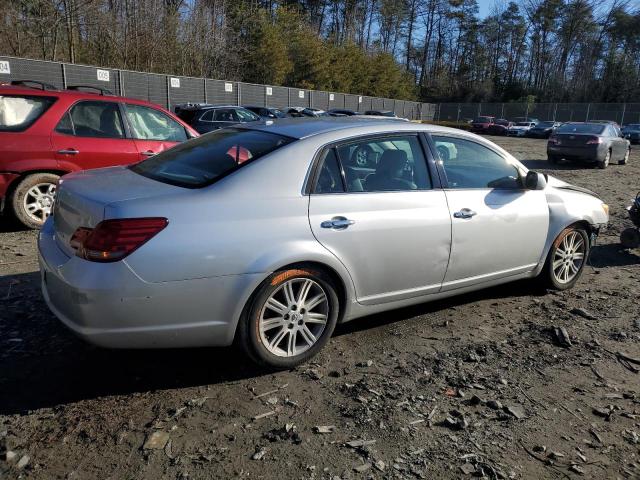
[238,267,340,370]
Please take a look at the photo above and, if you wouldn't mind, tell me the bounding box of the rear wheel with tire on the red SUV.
[11,173,60,228]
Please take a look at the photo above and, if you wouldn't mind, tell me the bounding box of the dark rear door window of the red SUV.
[56,100,125,138]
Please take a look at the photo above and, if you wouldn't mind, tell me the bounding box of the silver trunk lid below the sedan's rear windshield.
[53,167,185,255]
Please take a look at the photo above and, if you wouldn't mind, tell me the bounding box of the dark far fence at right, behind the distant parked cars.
[434,103,640,125]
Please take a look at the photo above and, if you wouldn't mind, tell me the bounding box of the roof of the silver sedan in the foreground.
[241,116,461,139]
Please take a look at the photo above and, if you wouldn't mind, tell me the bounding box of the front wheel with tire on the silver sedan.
[542,226,590,290]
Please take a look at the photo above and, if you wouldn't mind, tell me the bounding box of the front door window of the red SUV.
[127,104,187,142]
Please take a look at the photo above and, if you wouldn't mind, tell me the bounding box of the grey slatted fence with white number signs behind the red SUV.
[0,56,435,120]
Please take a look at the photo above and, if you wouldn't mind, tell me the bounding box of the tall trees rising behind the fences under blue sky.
[0,0,640,102]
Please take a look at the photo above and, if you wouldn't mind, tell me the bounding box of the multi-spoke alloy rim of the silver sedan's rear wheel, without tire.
[258,278,329,357]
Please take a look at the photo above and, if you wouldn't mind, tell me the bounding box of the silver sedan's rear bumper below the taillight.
[38,220,255,348]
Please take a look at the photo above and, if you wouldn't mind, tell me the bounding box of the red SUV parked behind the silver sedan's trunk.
[0,81,198,228]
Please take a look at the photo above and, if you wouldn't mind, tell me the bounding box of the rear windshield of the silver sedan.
[131,128,294,188]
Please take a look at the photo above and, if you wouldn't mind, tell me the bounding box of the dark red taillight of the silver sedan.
[69,218,169,262]
